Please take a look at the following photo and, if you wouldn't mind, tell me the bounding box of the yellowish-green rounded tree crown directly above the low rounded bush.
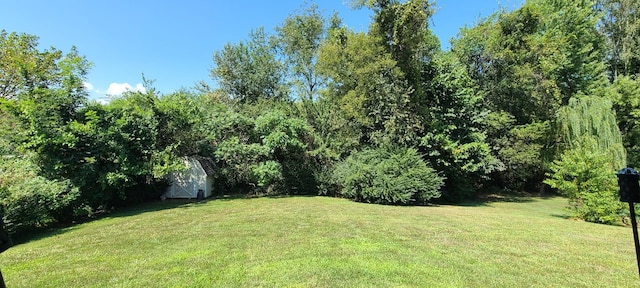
[319,27,420,145]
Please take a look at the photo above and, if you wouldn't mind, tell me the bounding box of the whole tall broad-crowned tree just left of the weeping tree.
[452,0,607,194]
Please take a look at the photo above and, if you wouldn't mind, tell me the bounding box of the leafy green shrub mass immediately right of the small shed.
[209,110,316,194]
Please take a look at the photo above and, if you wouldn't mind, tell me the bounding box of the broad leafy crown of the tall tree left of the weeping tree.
[452,0,606,125]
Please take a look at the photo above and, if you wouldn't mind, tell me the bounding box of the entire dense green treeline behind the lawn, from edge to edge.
[0,0,640,232]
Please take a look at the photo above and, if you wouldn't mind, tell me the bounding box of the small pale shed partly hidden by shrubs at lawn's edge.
[164,157,214,198]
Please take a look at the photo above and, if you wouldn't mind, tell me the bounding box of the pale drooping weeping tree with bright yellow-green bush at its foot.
[545,97,626,224]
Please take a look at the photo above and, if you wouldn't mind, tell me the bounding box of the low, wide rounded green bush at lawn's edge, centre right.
[334,148,444,204]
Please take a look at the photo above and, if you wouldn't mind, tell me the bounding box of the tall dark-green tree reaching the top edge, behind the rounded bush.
[354,0,501,200]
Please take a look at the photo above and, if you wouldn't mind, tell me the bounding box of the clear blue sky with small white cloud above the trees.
[0,0,523,99]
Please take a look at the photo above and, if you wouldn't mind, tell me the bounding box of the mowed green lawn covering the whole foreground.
[0,197,640,287]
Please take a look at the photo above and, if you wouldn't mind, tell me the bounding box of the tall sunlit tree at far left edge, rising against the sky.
[0,33,91,175]
